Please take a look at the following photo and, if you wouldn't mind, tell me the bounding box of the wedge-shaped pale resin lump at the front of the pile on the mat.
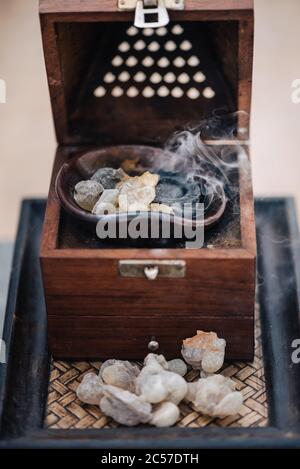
[100,385,152,427]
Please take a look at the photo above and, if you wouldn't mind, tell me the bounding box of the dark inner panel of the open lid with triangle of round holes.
[58,22,237,144]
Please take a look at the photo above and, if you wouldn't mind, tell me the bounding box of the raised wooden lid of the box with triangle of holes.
[40,0,253,144]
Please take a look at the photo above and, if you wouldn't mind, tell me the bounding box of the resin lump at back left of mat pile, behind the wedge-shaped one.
[101,360,140,392]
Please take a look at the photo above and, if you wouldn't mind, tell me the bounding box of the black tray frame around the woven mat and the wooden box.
[0,198,300,449]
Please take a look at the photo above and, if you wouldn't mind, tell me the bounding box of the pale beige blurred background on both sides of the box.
[0,0,300,240]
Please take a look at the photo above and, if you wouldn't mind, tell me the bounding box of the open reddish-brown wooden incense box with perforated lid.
[40,0,256,360]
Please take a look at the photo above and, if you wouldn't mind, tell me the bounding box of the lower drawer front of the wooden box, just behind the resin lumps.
[48,314,254,360]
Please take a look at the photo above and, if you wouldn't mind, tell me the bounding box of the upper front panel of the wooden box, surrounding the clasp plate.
[42,253,255,318]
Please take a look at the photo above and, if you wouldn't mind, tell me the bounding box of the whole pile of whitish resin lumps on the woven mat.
[76,331,243,427]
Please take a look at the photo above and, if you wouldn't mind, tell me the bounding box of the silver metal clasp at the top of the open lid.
[118,0,184,28]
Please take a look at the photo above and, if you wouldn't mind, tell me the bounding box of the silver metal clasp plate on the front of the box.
[119,259,186,281]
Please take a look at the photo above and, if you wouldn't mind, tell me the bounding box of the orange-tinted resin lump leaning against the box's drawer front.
[181,331,226,373]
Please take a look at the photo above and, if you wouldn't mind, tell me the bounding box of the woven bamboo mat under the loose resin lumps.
[45,306,268,429]
